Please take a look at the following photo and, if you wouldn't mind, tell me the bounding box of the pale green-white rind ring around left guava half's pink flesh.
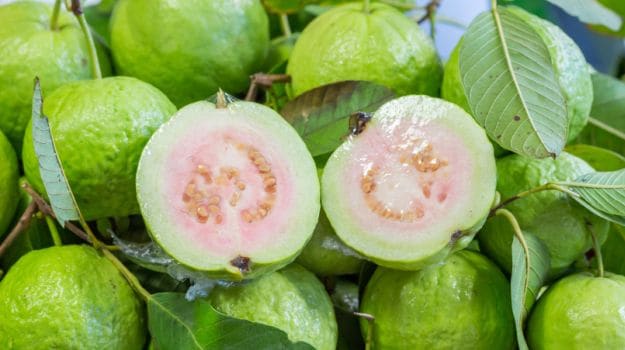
[136,101,320,280]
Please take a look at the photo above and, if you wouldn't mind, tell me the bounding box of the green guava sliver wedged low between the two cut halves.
[296,210,363,276]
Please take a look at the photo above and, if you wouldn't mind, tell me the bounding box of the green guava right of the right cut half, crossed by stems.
[478,152,609,277]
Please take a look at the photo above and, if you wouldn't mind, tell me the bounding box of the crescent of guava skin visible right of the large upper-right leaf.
[509,7,593,142]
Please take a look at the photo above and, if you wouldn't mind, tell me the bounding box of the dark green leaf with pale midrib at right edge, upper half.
[578,73,625,154]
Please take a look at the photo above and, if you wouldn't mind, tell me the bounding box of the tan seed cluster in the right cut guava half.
[360,142,448,222]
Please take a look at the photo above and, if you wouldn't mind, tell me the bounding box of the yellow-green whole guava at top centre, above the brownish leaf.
[287,3,442,95]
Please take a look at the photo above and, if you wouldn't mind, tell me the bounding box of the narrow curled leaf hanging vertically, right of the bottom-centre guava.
[510,232,550,350]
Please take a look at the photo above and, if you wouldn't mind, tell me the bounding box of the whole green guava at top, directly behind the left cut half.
[110,0,269,107]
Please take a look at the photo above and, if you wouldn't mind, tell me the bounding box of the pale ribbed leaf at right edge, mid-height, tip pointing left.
[558,169,625,225]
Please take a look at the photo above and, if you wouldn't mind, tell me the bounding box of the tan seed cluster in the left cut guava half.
[182,144,277,224]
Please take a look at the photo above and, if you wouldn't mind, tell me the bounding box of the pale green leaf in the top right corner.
[547,0,623,31]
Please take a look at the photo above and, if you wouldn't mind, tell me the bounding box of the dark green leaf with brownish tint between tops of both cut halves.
[280,81,395,157]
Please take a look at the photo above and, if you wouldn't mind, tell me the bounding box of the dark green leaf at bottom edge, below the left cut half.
[148,293,313,350]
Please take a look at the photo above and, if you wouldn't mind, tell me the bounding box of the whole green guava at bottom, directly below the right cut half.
[361,250,515,349]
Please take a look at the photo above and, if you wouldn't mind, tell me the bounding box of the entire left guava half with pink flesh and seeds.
[137,97,320,280]
